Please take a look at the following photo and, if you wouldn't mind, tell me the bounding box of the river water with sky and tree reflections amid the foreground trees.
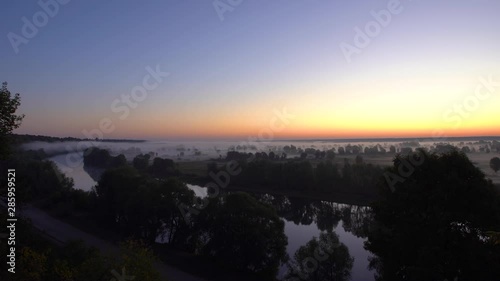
[182,184,375,281]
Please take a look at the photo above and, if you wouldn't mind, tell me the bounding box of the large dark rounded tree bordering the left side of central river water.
[196,192,288,280]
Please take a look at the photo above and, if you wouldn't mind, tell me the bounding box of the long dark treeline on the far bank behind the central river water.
[215,152,384,196]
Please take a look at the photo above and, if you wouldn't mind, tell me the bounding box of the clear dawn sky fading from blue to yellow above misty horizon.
[0,0,500,140]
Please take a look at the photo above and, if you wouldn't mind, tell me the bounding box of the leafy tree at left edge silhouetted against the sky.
[0,82,24,159]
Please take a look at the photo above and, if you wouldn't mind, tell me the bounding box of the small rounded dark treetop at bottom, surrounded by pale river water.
[286,232,354,281]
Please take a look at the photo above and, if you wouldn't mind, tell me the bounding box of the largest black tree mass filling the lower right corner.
[365,150,500,281]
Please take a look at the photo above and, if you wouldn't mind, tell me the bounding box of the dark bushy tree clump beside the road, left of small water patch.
[94,167,194,243]
